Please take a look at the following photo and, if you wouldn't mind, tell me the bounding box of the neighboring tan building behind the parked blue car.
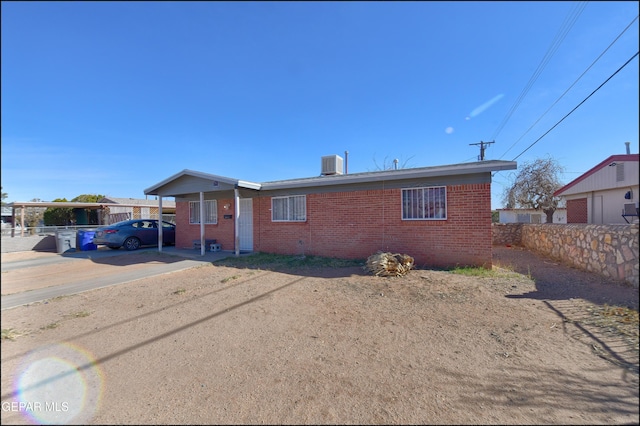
[98,197,176,223]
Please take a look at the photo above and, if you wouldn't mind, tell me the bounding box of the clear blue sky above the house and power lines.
[1,1,639,208]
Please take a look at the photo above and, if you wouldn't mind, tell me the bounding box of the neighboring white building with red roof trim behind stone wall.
[554,150,640,224]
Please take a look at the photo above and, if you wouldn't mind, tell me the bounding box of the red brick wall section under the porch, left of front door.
[176,199,235,250]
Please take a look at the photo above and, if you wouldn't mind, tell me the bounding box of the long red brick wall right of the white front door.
[253,183,492,267]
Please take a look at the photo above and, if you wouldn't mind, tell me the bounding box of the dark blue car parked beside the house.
[93,219,176,250]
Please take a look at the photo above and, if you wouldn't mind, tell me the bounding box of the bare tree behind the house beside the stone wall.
[502,158,564,223]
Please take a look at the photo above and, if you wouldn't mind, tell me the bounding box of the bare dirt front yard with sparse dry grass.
[1,247,639,425]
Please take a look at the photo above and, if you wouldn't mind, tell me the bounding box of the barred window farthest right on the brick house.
[402,186,447,220]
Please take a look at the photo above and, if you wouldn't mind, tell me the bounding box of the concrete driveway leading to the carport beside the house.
[1,247,235,309]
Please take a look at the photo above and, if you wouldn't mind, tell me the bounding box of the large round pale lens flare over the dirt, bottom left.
[15,343,103,424]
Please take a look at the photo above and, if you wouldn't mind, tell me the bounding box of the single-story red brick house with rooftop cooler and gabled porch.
[144,156,516,267]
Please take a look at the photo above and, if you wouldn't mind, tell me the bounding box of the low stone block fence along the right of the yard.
[492,223,640,288]
